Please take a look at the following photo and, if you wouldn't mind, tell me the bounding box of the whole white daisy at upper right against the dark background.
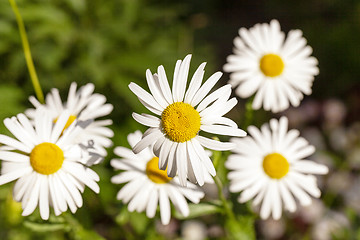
[224,20,319,112]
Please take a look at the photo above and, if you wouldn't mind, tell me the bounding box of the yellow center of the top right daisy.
[260,53,284,77]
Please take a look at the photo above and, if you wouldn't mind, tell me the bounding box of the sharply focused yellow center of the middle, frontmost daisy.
[161,102,201,142]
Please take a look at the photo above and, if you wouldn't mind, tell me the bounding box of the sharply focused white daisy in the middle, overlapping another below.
[129,55,246,186]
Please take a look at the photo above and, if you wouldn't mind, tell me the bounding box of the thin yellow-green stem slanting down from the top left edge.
[9,0,45,103]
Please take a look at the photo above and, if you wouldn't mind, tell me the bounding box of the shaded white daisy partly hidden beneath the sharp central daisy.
[110,131,204,225]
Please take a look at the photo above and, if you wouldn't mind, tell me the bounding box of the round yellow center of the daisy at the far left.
[30,142,64,175]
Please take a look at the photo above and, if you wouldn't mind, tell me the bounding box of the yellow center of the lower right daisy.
[263,153,289,179]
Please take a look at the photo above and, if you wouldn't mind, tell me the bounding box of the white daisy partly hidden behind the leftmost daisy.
[26,82,114,165]
